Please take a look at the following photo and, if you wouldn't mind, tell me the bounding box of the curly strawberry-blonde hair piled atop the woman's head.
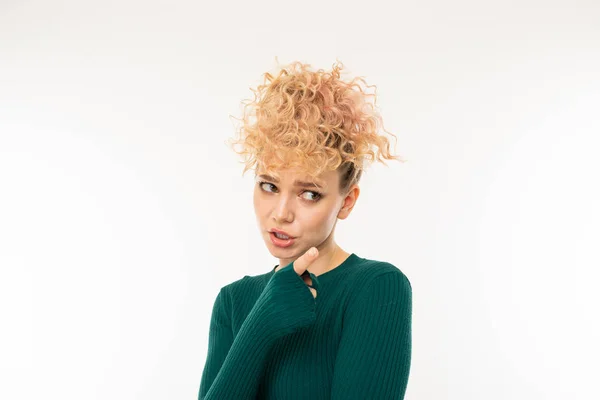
[227,59,405,193]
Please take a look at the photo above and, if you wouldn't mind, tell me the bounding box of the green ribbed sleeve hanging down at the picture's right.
[331,269,412,400]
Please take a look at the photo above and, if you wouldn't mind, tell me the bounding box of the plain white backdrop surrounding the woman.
[0,0,600,400]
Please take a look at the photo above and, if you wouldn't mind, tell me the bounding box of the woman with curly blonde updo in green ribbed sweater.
[198,62,412,400]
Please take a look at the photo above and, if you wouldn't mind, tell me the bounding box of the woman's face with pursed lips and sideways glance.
[254,165,358,265]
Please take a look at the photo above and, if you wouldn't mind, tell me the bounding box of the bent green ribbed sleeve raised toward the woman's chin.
[198,263,318,400]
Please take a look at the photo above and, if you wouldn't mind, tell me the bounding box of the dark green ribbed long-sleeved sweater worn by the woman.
[198,253,412,400]
